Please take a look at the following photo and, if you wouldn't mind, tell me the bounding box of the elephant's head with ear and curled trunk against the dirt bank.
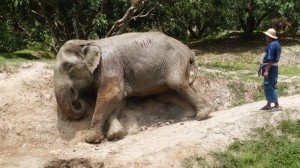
[54,40,101,119]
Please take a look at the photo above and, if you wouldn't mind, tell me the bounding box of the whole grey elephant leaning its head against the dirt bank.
[54,32,211,143]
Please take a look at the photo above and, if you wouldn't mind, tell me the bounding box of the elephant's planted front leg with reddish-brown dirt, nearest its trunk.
[85,81,123,143]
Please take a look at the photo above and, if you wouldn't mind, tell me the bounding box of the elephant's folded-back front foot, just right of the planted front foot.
[107,120,126,140]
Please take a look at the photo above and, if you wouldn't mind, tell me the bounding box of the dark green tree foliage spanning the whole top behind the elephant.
[0,0,300,57]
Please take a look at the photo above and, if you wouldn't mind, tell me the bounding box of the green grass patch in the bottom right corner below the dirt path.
[182,115,300,168]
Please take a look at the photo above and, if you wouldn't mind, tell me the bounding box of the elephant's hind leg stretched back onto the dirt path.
[171,84,211,120]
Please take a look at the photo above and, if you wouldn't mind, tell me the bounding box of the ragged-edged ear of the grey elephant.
[82,44,101,73]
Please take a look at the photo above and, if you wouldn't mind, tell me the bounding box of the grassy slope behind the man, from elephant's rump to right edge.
[191,34,300,106]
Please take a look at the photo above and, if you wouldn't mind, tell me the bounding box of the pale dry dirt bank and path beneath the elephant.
[0,62,300,168]
